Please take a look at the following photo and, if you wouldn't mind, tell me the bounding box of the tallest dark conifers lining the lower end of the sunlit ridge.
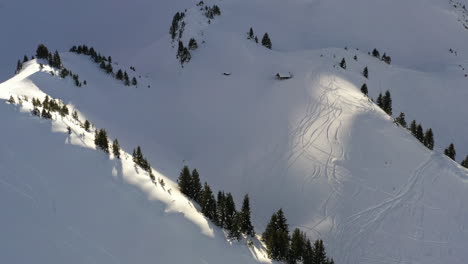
[177,166,334,264]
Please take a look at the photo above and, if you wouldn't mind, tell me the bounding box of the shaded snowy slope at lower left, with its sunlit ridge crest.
[0,62,269,263]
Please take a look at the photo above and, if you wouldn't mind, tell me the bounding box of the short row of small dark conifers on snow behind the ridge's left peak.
[70,45,138,86]
